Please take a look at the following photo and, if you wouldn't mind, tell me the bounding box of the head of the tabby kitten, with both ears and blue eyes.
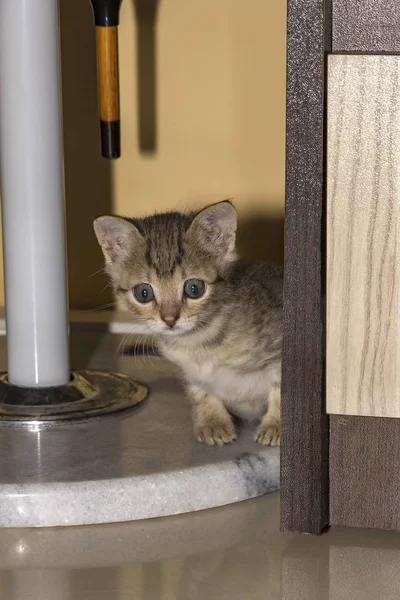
[94,201,237,336]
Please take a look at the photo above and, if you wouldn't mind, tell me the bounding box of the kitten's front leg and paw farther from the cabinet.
[187,385,236,446]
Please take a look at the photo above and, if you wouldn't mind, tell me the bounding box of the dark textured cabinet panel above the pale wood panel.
[332,0,400,54]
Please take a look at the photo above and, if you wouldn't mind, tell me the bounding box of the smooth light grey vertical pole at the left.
[0,0,70,387]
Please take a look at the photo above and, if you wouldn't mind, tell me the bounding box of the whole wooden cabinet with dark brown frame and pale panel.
[281,0,400,533]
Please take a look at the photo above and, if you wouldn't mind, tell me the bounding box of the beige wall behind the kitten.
[0,0,286,306]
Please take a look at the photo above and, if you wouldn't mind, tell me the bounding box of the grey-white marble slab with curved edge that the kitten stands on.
[0,327,280,527]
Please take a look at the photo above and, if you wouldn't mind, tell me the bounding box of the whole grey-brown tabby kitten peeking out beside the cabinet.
[94,201,282,446]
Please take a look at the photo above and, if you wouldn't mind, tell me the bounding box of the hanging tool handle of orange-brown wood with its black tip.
[96,26,121,159]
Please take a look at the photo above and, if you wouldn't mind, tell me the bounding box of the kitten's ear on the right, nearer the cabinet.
[189,200,237,255]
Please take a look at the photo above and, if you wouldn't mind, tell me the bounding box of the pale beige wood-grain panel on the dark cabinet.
[327,56,400,417]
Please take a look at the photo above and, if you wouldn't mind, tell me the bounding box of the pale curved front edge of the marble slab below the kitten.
[0,448,280,527]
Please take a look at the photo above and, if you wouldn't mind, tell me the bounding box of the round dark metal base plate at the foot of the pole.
[0,371,148,426]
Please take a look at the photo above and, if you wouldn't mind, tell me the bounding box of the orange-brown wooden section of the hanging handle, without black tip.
[96,27,120,122]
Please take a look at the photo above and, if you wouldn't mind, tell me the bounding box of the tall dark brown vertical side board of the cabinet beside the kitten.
[281,0,328,533]
